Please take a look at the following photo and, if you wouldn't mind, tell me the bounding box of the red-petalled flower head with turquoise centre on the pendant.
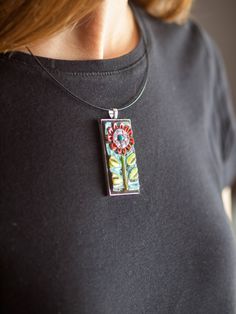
[106,122,134,155]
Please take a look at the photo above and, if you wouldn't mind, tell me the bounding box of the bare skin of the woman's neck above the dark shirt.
[20,0,140,60]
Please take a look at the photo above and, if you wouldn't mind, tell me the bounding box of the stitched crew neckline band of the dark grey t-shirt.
[0,0,147,73]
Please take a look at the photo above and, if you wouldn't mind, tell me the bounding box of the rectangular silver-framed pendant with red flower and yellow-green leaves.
[99,119,140,196]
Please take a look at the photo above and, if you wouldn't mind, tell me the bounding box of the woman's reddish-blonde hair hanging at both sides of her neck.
[0,0,192,52]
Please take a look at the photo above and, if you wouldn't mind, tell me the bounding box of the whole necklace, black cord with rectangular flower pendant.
[26,2,149,196]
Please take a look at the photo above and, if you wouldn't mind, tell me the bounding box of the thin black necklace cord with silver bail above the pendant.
[26,2,149,118]
